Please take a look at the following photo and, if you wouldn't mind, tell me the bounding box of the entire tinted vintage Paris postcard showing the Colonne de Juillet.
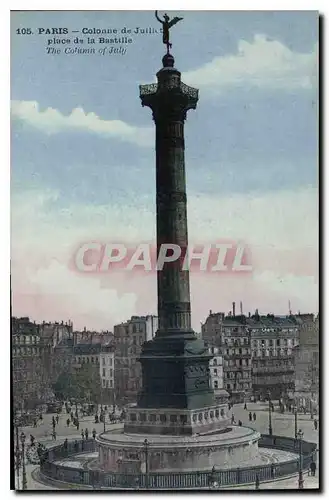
[10,10,321,492]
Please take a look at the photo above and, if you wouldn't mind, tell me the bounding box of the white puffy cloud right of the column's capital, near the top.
[183,35,318,92]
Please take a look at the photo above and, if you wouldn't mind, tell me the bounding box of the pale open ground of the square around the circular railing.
[15,403,319,490]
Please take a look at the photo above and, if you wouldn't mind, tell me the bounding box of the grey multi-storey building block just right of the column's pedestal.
[202,303,306,402]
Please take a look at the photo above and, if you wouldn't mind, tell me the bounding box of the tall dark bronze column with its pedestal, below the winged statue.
[138,53,214,416]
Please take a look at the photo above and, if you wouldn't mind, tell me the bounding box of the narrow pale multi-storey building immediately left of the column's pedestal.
[113,315,158,402]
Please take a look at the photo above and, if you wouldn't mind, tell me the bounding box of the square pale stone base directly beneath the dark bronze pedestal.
[124,403,230,436]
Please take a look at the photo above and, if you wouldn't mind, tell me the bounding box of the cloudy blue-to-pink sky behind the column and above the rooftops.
[11,11,318,330]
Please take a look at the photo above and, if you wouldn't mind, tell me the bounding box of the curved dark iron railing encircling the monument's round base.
[40,435,317,489]
